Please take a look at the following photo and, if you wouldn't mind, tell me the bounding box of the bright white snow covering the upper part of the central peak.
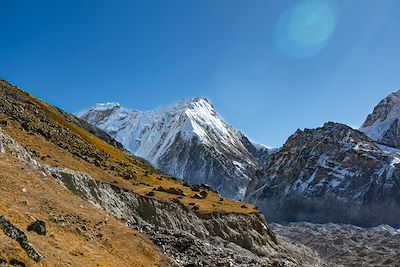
[78,98,253,164]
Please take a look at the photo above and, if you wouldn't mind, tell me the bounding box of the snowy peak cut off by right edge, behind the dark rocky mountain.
[360,91,400,148]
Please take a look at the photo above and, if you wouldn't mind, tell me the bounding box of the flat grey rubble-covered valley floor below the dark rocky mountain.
[271,223,400,267]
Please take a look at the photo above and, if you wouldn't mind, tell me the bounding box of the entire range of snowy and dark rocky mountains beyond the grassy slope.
[79,92,400,226]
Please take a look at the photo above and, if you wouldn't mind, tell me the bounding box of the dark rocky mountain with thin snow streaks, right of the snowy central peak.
[246,123,400,227]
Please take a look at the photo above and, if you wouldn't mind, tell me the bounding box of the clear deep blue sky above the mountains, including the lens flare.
[0,0,400,146]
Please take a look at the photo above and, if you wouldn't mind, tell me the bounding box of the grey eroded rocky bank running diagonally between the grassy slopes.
[0,127,319,266]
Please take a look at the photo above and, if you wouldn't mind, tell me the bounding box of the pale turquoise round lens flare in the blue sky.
[275,0,337,58]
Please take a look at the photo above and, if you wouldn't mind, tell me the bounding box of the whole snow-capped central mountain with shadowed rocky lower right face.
[79,98,269,199]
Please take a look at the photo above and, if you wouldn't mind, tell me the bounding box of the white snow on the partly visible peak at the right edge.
[360,90,400,141]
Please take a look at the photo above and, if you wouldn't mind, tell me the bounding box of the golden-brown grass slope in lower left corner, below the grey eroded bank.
[0,154,169,266]
